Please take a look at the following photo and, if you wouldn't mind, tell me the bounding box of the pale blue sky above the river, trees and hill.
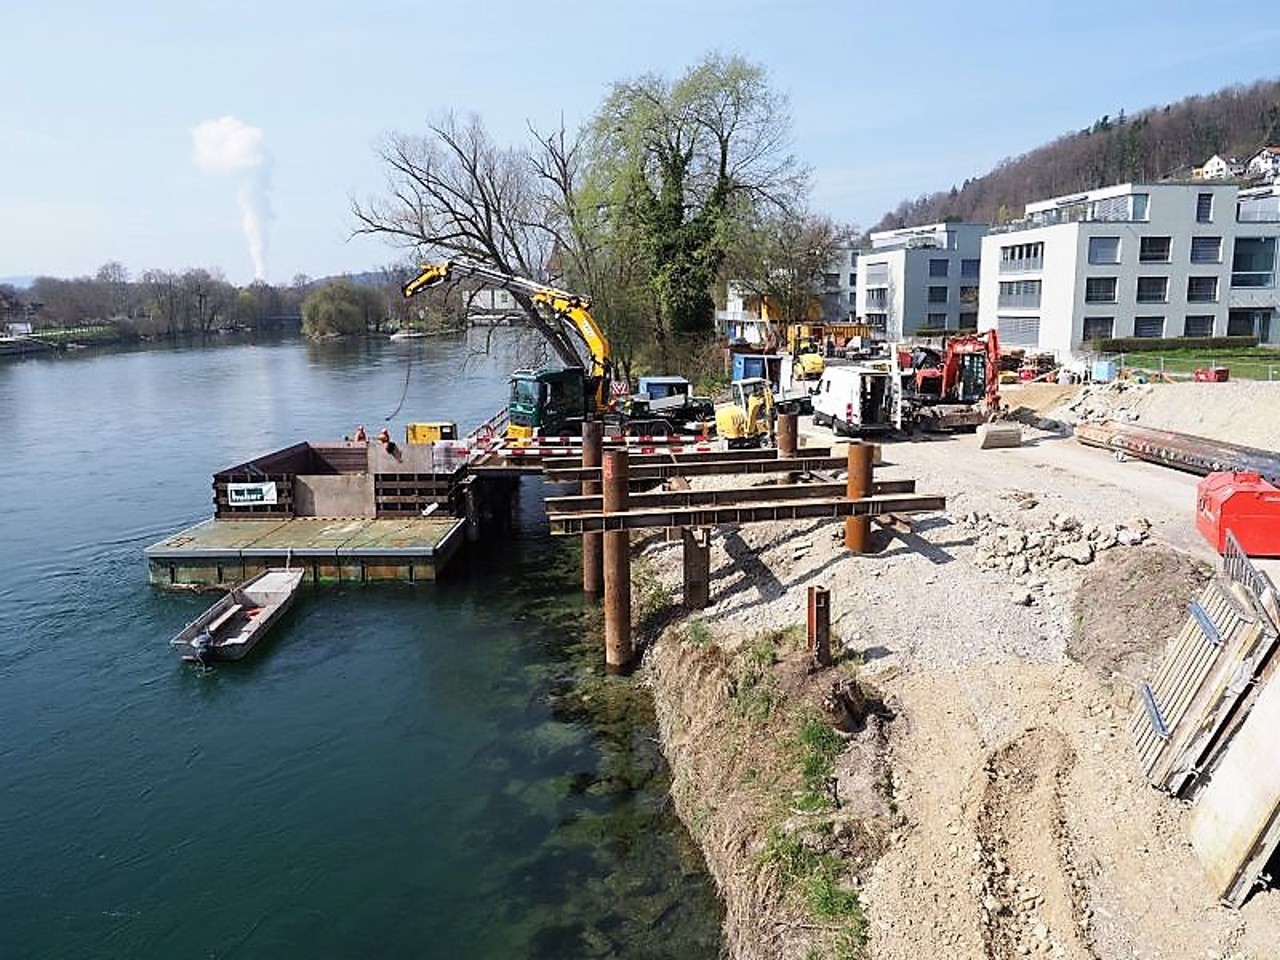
[0,0,1280,285]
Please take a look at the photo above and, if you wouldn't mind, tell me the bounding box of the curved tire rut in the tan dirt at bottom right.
[977,728,1097,960]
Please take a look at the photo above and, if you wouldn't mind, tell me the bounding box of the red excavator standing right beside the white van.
[902,330,1000,430]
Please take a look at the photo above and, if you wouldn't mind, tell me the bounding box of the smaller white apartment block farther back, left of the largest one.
[855,223,989,342]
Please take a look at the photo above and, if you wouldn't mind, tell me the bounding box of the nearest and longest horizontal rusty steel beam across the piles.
[550,494,947,535]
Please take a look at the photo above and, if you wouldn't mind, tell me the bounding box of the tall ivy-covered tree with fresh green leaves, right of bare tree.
[593,55,806,337]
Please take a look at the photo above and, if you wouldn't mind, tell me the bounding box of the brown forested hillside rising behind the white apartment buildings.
[870,81,1280,230]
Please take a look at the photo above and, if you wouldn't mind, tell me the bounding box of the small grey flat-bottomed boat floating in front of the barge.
[169,567,305,663]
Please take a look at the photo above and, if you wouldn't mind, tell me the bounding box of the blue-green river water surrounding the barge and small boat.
[0,334,722,960]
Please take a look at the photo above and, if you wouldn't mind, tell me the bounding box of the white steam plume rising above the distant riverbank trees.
[191,116,271,280]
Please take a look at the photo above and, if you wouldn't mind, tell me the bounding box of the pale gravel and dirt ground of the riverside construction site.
[644,383,1280,960]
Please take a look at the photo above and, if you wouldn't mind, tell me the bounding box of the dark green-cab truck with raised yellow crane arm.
[401,260,701,439]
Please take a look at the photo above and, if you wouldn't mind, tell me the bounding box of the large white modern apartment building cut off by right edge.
[978,180,1280,361]
